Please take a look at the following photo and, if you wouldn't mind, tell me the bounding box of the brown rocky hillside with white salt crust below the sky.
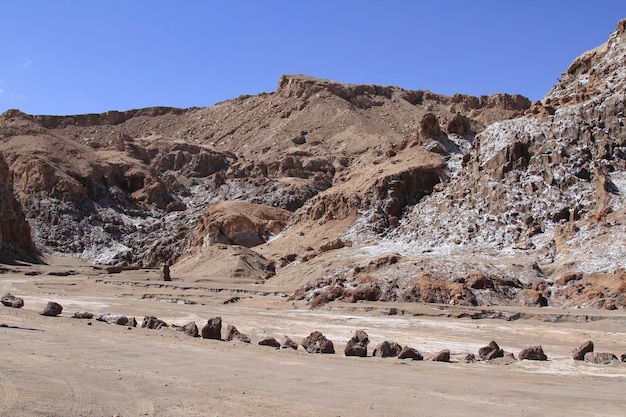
[0,21,626,308]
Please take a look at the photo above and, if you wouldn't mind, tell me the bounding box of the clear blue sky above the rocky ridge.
[0,0,626,114]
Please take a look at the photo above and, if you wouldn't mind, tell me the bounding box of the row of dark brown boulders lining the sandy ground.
[0,293,626,365]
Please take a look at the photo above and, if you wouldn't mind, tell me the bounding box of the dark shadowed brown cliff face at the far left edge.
[0,151,37,261]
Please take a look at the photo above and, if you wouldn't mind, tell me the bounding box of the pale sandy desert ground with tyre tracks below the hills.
[0,254,626,417]
